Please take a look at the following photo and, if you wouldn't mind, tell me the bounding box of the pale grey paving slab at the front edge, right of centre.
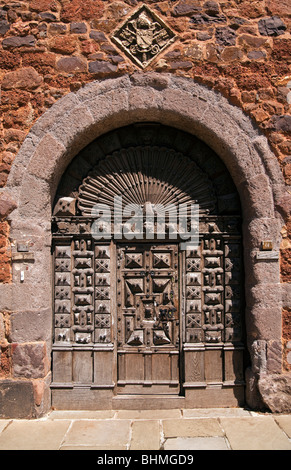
[164,437,229,450]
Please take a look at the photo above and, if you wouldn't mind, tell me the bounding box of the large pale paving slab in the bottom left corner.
[0,420,71,450]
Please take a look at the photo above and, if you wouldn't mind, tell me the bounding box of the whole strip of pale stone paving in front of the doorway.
[0,408,291,451]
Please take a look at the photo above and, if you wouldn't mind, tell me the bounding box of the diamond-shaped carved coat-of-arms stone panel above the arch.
[112,5,175,68]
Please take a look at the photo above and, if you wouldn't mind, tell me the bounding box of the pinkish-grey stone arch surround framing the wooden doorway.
[0,73,285,412]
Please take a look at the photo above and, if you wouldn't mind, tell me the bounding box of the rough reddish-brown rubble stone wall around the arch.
[0,0,291,414]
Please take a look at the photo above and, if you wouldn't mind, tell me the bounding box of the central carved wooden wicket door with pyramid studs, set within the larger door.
[117,244,180,394]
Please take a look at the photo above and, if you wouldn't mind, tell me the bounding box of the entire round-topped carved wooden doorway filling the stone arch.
[51,123,247,408]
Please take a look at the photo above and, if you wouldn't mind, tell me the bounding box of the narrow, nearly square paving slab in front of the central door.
[130,420,161,450]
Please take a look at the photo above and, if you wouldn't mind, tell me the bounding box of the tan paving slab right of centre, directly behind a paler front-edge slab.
[162,418,224,438]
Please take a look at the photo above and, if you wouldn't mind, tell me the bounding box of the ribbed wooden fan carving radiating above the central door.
[77,146,216,216]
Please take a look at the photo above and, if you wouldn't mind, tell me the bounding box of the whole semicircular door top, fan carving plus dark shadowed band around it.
[54,123,240,217]
